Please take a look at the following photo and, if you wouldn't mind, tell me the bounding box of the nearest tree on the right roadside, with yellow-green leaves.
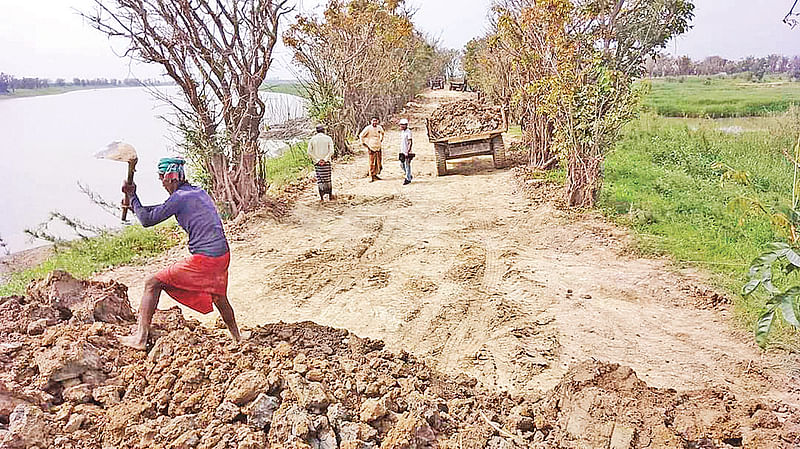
[521,0,694,206]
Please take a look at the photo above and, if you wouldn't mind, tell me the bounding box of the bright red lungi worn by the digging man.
[156,253,231,313]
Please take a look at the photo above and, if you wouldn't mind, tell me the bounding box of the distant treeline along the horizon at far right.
[645,55,800,81]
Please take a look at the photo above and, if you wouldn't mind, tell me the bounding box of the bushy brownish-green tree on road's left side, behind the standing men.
[284,0,446,151]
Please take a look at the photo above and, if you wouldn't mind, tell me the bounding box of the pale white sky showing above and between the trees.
[0,0,800,79]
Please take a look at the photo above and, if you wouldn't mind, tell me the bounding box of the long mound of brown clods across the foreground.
[0,273,800,449]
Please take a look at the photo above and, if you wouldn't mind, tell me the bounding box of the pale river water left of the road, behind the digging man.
[0,83,305,252]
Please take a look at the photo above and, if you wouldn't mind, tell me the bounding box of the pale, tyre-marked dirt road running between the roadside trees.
[101,91,800,404]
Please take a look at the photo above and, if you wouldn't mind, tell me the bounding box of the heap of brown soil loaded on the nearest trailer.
[428,100,505,140]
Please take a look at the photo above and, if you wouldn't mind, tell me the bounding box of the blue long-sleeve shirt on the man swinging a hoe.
[131,184,228,257]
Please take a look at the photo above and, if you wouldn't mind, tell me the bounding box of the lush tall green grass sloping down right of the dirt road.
[600,115,800,348]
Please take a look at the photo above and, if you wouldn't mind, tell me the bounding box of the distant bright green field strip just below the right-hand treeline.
[644,76,800,118]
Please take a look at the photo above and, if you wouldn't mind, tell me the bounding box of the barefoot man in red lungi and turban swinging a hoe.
[120,158,241,349]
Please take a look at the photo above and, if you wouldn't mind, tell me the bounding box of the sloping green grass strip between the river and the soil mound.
[0,220,183,296]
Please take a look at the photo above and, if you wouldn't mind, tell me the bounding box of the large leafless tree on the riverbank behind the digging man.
[82,0,291,215]
